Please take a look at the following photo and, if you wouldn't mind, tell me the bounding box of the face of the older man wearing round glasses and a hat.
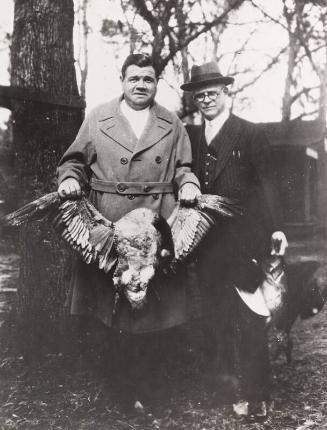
[193,84,228,121]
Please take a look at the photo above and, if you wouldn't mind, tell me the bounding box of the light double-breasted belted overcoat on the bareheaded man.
[58,99,199,333]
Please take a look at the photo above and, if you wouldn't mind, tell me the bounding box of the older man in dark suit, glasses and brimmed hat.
[181,62,286,420]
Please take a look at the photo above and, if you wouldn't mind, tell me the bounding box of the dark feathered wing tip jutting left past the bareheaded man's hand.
[1,192,61,226]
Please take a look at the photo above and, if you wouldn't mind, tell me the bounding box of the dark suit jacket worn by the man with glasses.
[186,115,280,290]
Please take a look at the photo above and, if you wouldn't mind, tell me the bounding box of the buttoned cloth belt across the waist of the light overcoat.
[90,178,174,194]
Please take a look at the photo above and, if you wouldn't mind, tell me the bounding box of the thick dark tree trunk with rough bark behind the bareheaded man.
[11,0,83,360]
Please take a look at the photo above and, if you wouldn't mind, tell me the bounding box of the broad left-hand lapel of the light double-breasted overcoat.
[100,99,137,152]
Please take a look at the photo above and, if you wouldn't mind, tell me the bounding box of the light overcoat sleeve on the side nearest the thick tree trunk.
[57,110,96,187]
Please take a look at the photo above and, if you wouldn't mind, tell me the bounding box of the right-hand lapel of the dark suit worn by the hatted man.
[210,115,241,179]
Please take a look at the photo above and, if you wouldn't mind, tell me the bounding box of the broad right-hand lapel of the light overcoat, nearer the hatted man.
[133,103,173,157]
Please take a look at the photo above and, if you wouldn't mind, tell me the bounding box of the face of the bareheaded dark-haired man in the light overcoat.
[122,64,158,110]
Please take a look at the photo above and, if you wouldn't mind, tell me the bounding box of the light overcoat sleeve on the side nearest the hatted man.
[175,119,200,189]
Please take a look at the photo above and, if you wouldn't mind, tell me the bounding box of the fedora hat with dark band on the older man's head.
[181,61,234,91]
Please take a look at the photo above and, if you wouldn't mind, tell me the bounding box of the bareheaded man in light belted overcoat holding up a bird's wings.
[58,54,200,414]
